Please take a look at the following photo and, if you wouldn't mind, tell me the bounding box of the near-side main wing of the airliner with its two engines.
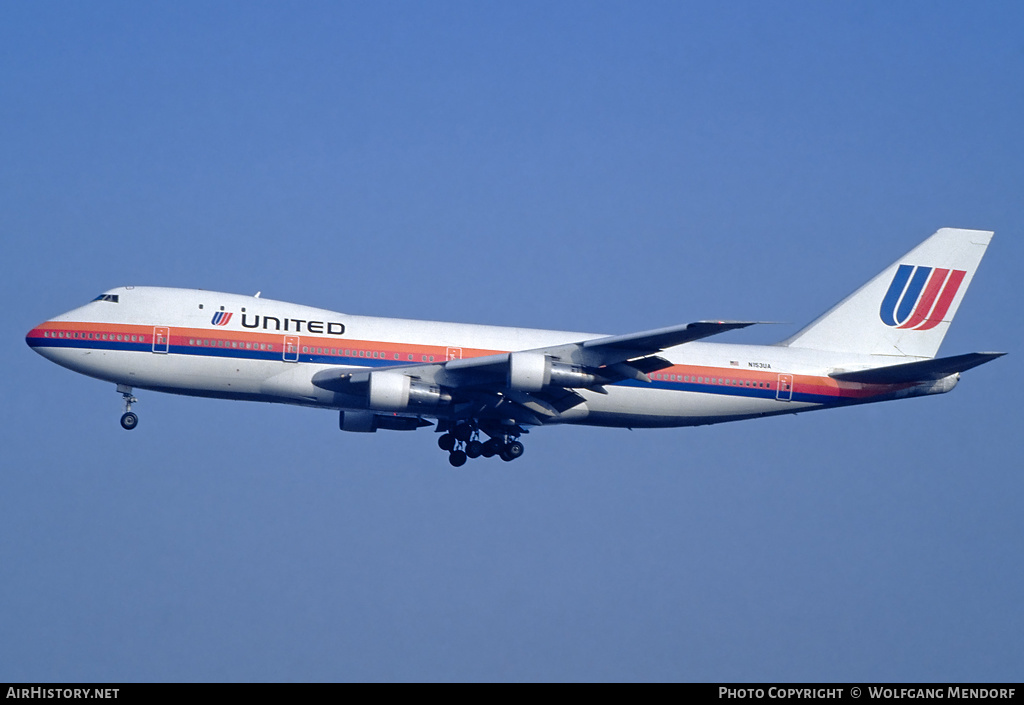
[312,321,756,424]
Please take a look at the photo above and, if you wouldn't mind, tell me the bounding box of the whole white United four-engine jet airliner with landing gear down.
[26,229,1002,466]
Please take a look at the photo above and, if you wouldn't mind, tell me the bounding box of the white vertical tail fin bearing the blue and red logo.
[782,227,992,358]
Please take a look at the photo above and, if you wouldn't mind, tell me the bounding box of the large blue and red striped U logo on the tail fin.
[879,264,967,330]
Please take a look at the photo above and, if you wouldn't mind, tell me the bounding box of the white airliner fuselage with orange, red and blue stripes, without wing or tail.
[27,287,955,427]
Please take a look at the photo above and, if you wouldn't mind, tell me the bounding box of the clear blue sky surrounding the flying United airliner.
[0,0,1024,681]
